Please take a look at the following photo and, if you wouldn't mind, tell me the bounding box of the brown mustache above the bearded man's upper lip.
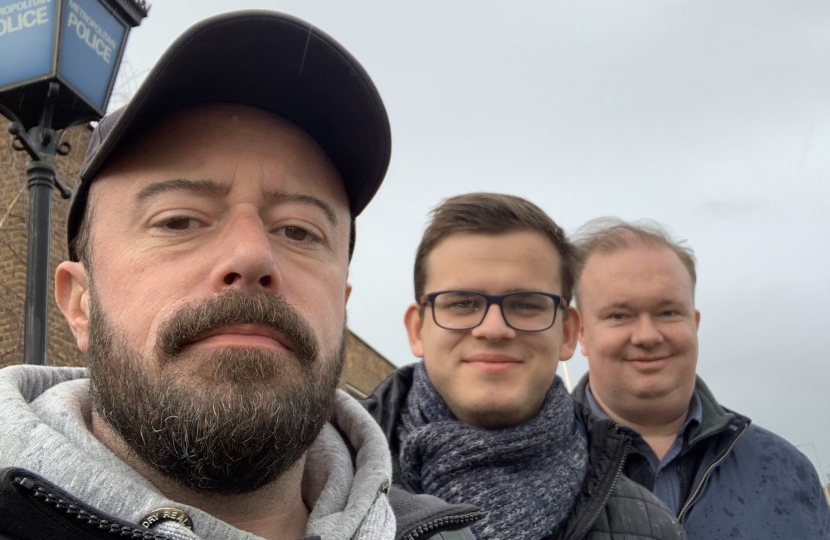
[156,290,320,362]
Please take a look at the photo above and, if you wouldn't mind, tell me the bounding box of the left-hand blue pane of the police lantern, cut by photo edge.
[0,0,55,87]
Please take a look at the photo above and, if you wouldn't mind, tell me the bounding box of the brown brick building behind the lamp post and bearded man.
[0,117,395,396]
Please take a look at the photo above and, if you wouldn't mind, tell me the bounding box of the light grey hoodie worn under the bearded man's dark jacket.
[0,366,395,540]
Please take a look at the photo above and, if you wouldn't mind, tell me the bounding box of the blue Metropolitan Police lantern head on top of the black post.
[0,0,147,129]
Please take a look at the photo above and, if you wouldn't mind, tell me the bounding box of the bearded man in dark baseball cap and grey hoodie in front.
[0,11,481,540]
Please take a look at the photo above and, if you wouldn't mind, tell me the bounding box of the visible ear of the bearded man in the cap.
[55,261,89,352]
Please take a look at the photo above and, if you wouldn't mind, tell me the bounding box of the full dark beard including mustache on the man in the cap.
[84,284,346,495]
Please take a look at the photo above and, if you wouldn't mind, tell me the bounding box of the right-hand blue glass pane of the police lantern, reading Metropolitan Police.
[57,0,127,108]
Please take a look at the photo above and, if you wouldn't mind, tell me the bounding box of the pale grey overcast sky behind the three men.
[116,0,830,482]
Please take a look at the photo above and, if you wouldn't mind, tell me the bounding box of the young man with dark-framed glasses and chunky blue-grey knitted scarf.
[364,193,685,540]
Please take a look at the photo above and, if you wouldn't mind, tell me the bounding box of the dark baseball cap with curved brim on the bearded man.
[67,10,392,261]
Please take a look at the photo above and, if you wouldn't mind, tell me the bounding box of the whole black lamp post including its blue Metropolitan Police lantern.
[0,0,149,365]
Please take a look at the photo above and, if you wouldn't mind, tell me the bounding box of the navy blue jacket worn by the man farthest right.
[574,375,830,540]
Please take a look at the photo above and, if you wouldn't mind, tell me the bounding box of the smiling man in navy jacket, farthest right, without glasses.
[574,219,830,540]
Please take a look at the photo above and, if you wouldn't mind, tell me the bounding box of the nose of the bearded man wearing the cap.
[210,210,280,291]
